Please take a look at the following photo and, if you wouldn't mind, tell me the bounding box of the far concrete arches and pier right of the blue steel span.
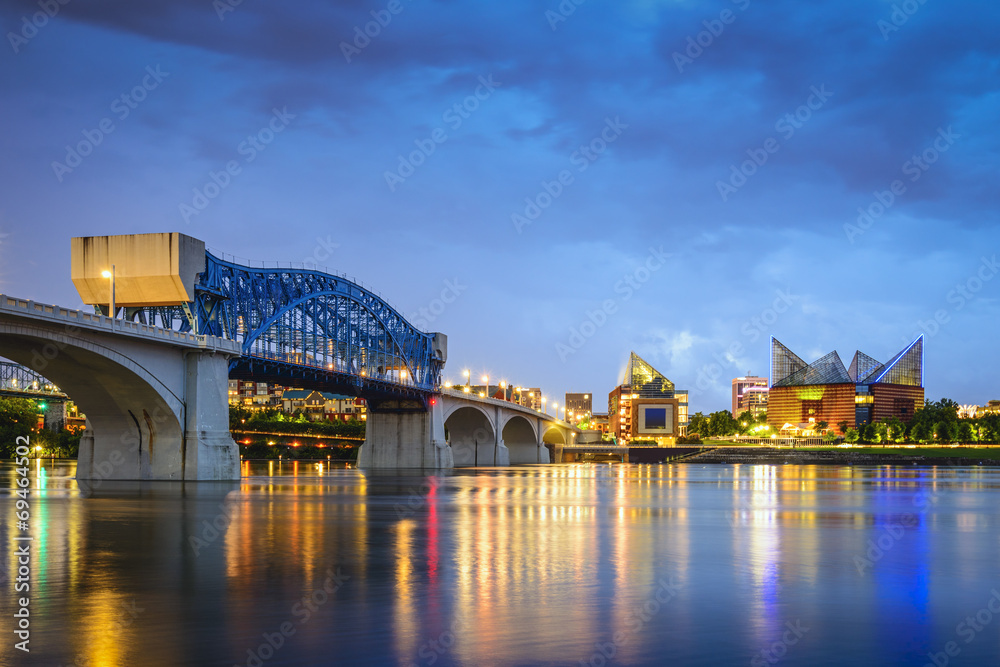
[358,389,579,468]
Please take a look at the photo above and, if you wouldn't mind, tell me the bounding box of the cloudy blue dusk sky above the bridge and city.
[0,0,1000,412]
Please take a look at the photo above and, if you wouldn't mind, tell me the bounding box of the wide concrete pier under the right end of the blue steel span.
[358,397,455,469]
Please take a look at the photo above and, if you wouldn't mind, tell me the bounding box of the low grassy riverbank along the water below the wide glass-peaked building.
[680,447,1000,466]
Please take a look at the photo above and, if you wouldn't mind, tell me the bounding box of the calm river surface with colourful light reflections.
[0,460,1000,667]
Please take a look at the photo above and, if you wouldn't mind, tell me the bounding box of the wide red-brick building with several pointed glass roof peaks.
[767,335,924,430]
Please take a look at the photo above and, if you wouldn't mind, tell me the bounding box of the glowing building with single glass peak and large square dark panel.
[608,352,688,445]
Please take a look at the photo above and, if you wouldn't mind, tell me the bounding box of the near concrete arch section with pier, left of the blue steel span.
[0,294,240,480]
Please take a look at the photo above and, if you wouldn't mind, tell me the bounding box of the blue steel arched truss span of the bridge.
[107,250,447,411]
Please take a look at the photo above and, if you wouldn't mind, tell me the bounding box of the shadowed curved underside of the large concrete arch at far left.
[0,322,185,479]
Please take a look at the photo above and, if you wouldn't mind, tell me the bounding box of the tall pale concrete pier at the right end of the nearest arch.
[182,351,240,480]
